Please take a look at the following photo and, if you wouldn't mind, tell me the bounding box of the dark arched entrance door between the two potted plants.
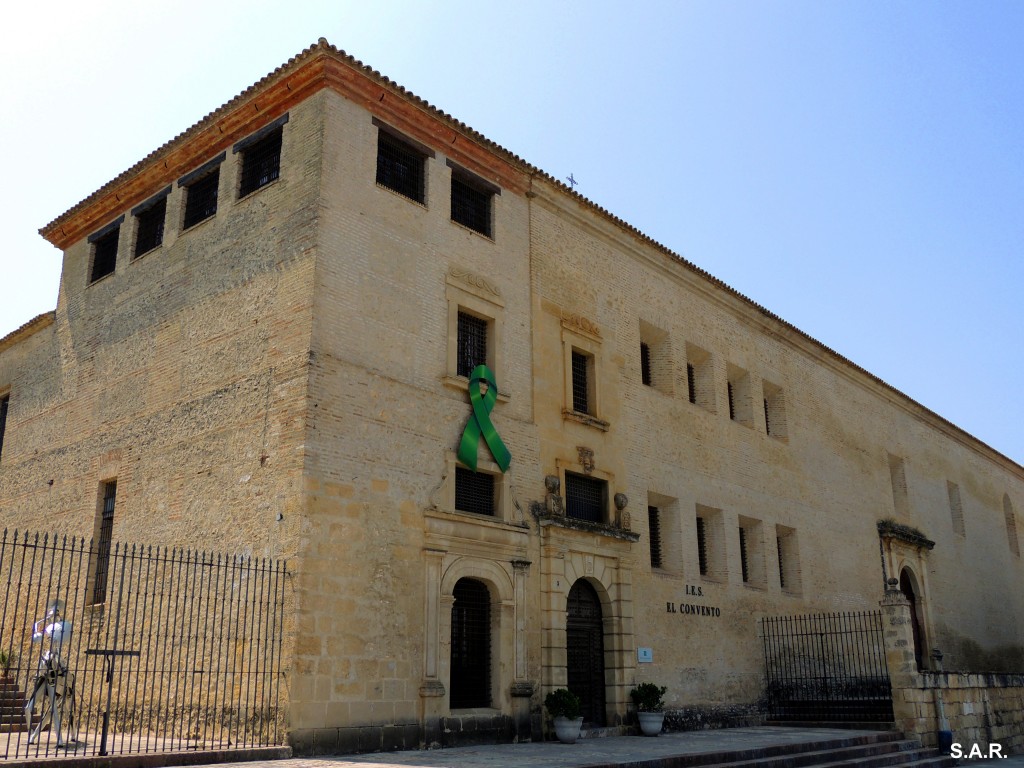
[565,579,604,727]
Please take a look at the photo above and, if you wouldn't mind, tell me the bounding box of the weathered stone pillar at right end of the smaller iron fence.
[879,579,921,741]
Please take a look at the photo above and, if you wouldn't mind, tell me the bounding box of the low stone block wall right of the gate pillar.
[893,672,1024,757]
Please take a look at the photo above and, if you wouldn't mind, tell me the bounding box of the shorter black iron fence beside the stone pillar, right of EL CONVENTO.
[761,611,893,723]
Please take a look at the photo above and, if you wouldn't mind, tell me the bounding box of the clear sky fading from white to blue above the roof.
[0,0,1024,463]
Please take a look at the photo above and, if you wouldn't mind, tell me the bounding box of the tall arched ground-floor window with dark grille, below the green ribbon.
[451,579,490,710]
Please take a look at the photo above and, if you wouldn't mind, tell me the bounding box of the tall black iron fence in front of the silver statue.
[0,530,288,758]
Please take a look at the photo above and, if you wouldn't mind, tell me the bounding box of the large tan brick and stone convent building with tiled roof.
[0,40,1024,752]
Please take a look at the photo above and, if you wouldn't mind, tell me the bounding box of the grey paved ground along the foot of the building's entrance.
[186,726,913,768]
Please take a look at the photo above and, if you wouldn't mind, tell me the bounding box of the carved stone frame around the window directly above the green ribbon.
[443,269,511,402]
